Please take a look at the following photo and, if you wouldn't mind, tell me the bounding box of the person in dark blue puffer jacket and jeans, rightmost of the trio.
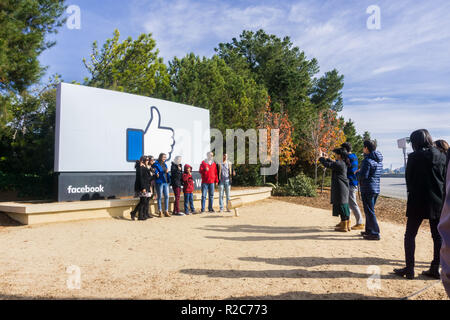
[358,140,383,240]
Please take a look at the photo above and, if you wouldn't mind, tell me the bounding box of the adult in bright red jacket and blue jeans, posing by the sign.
[199,152,219,213]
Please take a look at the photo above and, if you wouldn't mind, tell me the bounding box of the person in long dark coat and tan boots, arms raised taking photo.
[319,148,351,232]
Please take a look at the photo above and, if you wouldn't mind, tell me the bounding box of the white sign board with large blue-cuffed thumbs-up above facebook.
[54,83,210,172]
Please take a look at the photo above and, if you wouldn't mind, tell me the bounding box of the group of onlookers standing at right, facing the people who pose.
[319,129,450,279]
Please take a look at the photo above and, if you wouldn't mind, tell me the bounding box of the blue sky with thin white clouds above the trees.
[40,0,450,168]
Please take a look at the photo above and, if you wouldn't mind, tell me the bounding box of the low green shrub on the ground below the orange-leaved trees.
[269,173,317,197]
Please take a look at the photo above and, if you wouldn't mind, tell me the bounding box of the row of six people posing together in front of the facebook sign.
[131,152,235,220]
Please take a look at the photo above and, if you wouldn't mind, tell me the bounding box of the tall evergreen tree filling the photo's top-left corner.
[0,0,65,131]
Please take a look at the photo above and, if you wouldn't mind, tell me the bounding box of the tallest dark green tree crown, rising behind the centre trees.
[215,30,319,129]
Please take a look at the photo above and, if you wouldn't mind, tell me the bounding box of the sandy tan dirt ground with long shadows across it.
[0,199,446,299]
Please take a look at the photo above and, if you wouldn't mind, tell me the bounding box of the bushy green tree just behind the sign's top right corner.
[169,53,267,133]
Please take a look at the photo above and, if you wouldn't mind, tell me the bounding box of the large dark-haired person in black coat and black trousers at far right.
[394,129,447,279]
